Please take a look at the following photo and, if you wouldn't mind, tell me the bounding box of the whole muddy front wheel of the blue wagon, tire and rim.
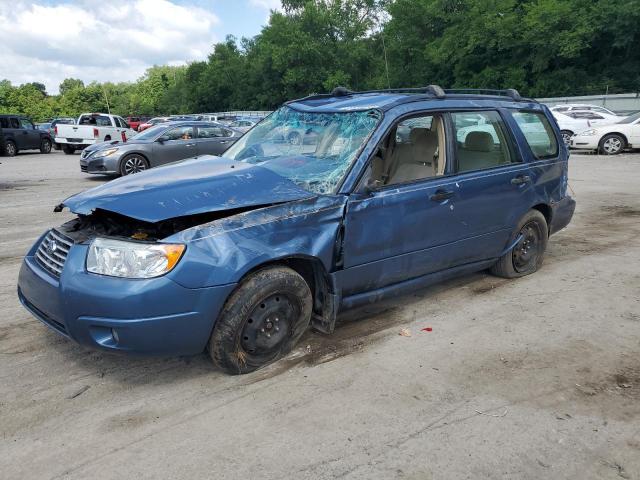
[209,266,312,375]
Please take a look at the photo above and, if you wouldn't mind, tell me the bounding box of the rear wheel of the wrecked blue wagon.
[490,210,549,278]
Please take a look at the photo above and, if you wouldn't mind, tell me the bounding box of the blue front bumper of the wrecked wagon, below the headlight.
[18,236,235,355]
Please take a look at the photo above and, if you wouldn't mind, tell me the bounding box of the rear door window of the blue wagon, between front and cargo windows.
[451,111,516,172]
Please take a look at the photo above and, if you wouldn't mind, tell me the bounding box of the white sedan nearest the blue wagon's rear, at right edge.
[570,112,640,155]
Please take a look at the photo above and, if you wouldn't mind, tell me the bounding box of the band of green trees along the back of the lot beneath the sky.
[0,0,640,121]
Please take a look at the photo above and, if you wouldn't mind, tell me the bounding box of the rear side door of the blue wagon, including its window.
[451,110,542,261]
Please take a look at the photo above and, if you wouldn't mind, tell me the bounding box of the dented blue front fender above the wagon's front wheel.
[163,195,347,288]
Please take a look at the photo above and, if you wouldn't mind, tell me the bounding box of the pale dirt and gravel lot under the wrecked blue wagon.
[0,153,640,480]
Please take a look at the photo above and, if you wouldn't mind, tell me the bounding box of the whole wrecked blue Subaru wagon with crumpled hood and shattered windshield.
[18,86,575,373]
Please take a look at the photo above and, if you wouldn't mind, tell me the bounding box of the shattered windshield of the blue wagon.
[223,106,381,194]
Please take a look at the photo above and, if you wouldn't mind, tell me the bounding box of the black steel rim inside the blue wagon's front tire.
[240,293,298,363]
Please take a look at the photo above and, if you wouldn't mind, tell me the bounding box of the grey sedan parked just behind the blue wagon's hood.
[80,122,242,175]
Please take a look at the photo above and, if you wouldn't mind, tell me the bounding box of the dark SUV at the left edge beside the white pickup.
[0,115,52,157]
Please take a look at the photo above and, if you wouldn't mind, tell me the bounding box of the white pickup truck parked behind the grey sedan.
[54,113,136,155]
